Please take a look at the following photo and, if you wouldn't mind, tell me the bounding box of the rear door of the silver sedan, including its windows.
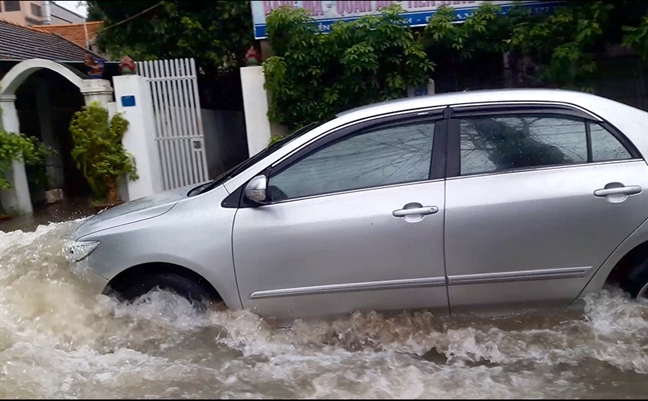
[445,105,648,313]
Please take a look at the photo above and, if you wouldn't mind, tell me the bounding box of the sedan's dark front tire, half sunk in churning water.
[110,273,212,311]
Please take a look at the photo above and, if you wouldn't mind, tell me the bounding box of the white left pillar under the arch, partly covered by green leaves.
[0,95,34,214]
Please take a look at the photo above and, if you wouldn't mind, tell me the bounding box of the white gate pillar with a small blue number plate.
[112,75,164,200]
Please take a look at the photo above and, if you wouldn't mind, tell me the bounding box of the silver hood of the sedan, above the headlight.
[72,185,198,239]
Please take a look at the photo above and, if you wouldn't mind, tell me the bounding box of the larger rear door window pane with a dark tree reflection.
[460,114,587,175]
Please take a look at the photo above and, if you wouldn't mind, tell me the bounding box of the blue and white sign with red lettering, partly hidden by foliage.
[250,0,562,39]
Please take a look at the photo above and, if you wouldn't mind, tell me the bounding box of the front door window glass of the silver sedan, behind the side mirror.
[268,121,435,201]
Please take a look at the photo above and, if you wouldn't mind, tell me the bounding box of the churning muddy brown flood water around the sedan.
[0,222,648,399]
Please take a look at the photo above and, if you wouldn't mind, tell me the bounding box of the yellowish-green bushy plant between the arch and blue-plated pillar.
[70,102,139,208]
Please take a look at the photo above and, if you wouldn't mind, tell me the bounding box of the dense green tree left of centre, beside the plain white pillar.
[264,5,434,129]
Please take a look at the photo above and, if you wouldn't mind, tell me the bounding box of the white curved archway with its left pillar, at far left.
[0,59,113,214]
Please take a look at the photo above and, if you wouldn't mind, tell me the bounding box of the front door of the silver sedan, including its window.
[233,112,448,320]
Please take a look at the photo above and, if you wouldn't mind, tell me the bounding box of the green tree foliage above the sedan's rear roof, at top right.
[423,1,648,91]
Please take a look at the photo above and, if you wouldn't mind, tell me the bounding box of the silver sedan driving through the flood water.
[67,90,648,321]
